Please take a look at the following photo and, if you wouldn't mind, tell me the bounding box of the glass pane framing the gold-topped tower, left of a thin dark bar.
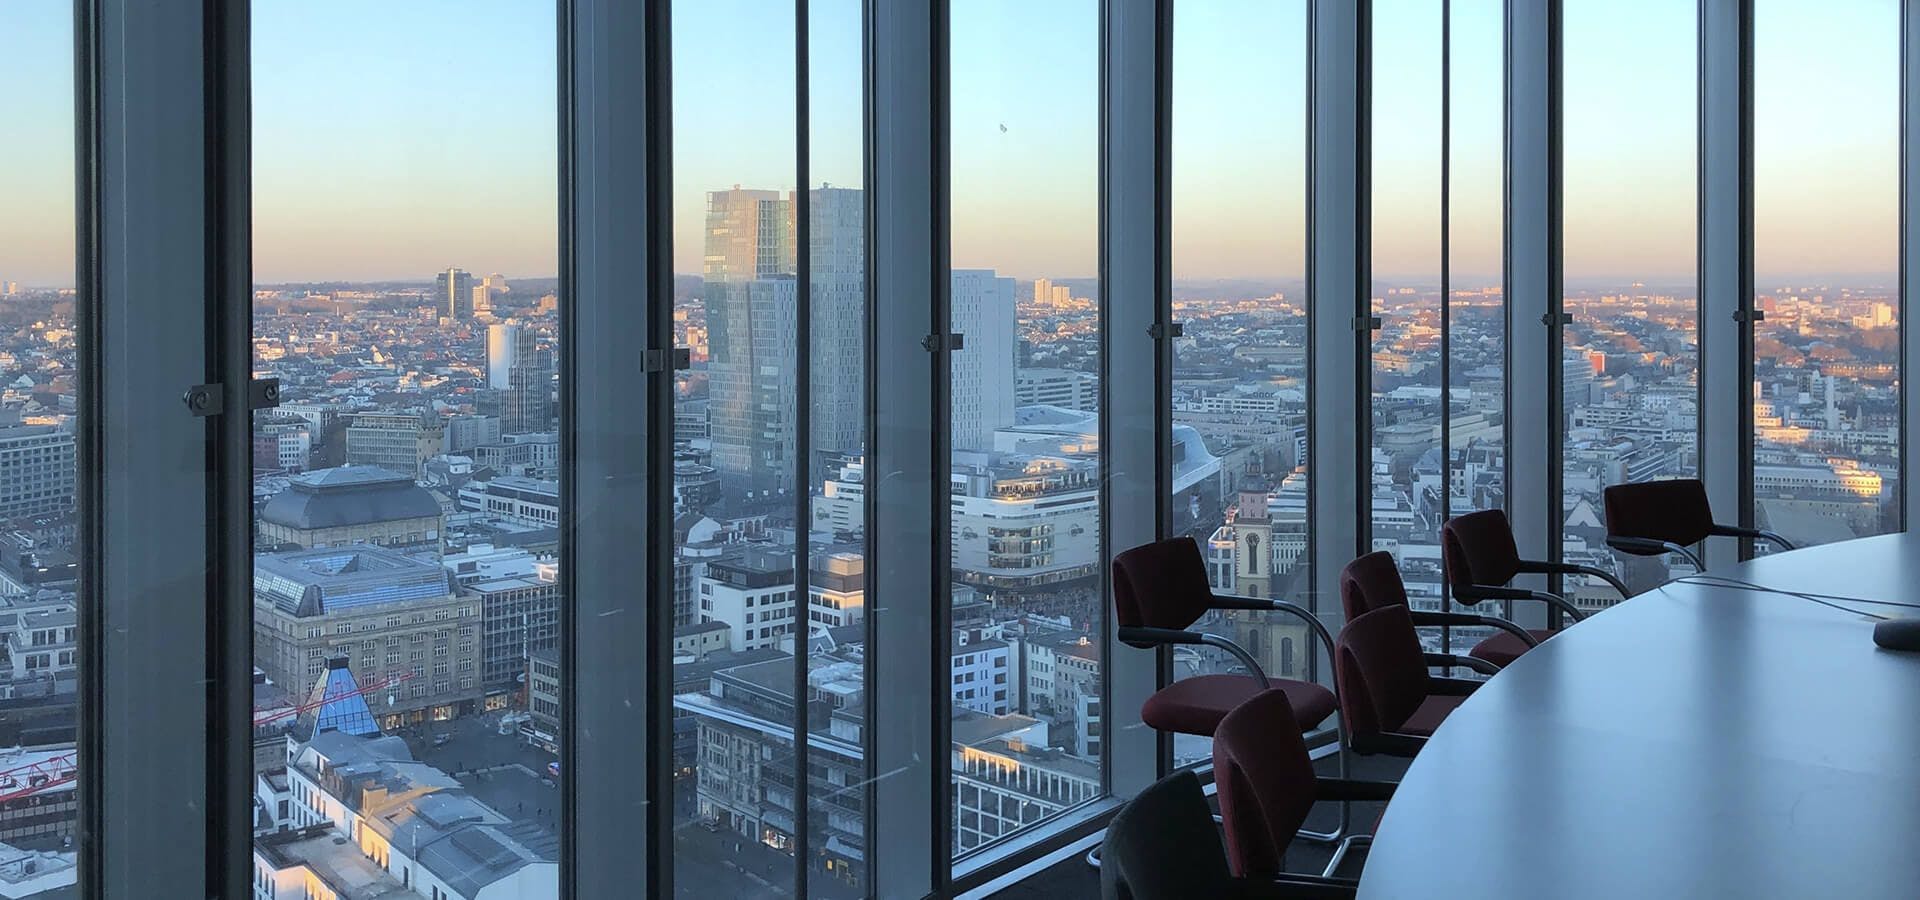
[672,0,802,898]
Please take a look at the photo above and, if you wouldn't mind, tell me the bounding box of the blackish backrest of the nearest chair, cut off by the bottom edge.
[1100,770,1233,900]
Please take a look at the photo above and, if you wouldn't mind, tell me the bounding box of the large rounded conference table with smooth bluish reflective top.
[1359,533,1920,900]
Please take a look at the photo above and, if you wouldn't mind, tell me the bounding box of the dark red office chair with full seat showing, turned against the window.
[1114,537,1346,841]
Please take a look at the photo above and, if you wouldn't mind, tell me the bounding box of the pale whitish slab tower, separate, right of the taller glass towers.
[952,269,1018,449]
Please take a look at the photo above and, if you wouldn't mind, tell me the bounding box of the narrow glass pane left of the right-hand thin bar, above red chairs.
[1374,0,1446,629]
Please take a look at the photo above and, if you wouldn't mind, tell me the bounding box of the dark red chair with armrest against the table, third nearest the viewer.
[1332,604,1484,756]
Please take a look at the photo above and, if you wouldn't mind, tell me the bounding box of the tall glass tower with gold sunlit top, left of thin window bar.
[703,186,795,491]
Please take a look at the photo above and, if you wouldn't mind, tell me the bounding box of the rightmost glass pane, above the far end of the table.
[1753,0,1901,553]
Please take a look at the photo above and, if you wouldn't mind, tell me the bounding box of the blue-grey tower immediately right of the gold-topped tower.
[806,186,866,486]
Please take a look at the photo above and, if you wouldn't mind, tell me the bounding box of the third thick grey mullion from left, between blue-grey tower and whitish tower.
[866,0,952,896]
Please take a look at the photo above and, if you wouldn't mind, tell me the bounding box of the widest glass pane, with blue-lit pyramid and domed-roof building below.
[252,0,563,898]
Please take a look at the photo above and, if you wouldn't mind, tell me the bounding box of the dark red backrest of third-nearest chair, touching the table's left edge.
[1334,604,1432,739]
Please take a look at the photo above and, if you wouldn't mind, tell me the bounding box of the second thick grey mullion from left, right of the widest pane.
[559,0,674,896]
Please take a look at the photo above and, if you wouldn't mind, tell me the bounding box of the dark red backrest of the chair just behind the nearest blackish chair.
[1213,691,1313,877]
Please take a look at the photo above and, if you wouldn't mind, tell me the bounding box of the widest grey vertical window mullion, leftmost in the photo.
[90,0,222,898]
